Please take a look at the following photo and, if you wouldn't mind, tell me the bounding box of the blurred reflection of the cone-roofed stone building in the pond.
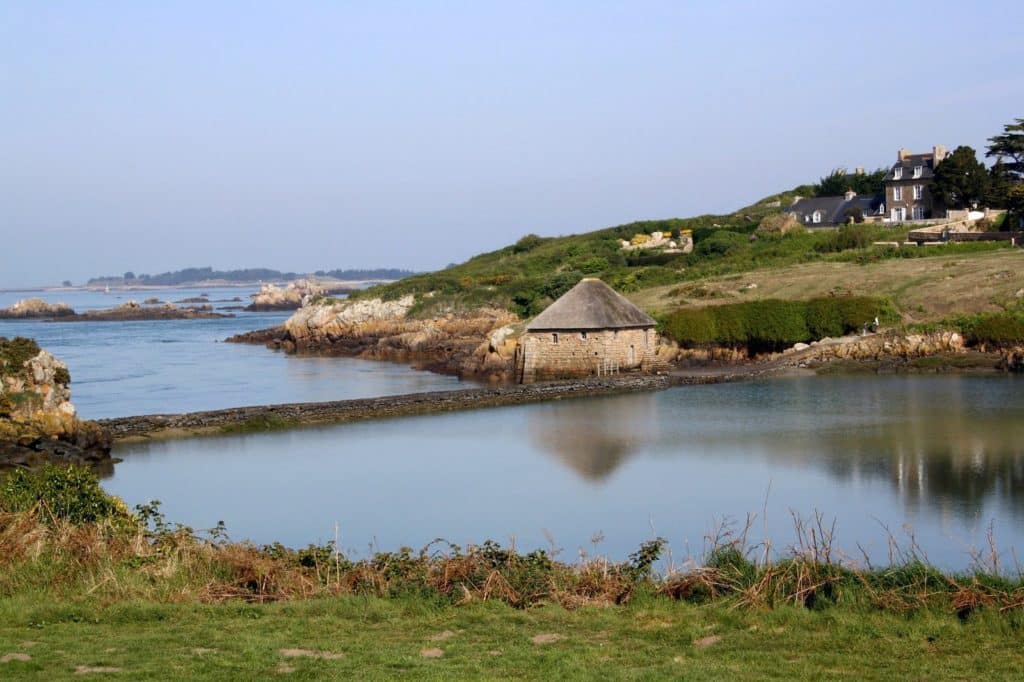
[527,393,659,482]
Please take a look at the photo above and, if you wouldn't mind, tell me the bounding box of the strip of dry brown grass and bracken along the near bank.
[0,503,1024,619]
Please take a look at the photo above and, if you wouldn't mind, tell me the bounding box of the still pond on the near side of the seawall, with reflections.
[104,377,1024,568]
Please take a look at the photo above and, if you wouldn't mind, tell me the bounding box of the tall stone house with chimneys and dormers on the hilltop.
[885,144,949,222]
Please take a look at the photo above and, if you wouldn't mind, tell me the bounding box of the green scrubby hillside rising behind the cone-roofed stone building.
[356,186,1007,317]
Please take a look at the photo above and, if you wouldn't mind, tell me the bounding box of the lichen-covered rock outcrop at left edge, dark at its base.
[0,337,111,468]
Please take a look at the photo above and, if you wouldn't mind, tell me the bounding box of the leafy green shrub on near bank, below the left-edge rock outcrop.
[0,464,132,524]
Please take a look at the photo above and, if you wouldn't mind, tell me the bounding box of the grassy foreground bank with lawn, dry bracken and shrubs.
[6,468,1024,679]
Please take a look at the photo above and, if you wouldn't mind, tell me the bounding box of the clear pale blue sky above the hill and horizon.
[0,0,1024,288]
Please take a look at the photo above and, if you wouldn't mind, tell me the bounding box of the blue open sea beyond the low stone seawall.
[0,288,459,419]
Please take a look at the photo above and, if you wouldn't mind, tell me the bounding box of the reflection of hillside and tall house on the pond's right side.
[659,377,1024,517]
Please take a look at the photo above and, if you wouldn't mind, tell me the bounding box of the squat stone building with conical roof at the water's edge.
[515,278,657,384]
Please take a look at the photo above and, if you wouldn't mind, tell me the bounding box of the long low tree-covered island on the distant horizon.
[81,267,416,287]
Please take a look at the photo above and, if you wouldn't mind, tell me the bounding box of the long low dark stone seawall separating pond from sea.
[98,375,688,440]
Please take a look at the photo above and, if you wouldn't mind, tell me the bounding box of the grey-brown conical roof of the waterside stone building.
[526,278,654,332]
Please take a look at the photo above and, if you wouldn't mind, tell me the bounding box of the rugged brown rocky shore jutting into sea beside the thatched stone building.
[227,296,519,381]
